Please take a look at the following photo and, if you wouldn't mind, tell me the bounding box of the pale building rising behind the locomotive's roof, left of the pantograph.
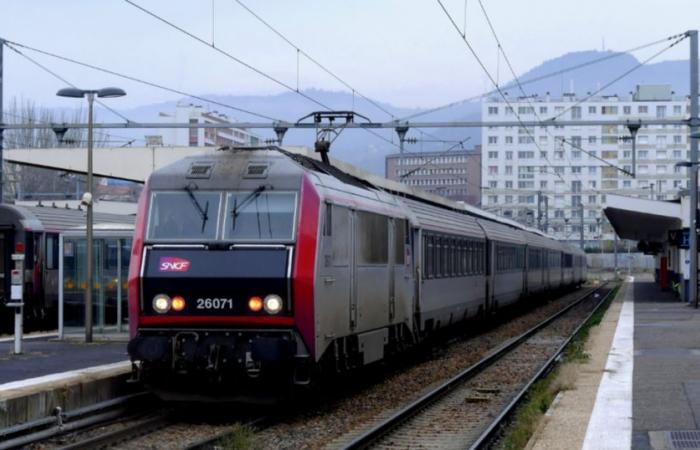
[145,102,260,147]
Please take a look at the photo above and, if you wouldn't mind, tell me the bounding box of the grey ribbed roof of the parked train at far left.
[0,204,135,233]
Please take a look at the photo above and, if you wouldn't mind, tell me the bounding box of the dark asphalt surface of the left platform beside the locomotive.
[0,338,129,384]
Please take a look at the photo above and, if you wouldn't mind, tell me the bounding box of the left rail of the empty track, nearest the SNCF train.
[344,283,607,450]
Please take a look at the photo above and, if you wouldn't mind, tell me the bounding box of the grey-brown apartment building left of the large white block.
[385,145,481,205]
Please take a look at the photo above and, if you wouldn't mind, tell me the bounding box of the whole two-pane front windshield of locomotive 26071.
[147,189,297,242]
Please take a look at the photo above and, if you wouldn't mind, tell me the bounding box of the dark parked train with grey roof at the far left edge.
[0,203,132,334]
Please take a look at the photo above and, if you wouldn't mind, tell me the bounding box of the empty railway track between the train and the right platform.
[343,285,612,449]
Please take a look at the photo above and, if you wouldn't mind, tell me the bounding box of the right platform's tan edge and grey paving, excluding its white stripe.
[528,275,700,450]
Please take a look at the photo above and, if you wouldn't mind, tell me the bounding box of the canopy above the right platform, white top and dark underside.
[603,194,683,242]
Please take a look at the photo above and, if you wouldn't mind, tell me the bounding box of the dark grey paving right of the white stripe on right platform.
[632,280,700,450]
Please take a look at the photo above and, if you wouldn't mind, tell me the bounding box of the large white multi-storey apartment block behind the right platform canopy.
[481,85,690,246]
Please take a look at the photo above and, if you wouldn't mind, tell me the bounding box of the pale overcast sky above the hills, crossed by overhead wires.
[0,0,700,116]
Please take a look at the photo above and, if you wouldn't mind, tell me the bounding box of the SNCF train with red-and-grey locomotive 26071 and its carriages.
[128,146,586,399]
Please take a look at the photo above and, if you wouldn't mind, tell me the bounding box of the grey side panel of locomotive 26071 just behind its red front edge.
[316,203,356,339]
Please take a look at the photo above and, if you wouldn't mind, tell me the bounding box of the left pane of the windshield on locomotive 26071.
[148,190,221,240]
